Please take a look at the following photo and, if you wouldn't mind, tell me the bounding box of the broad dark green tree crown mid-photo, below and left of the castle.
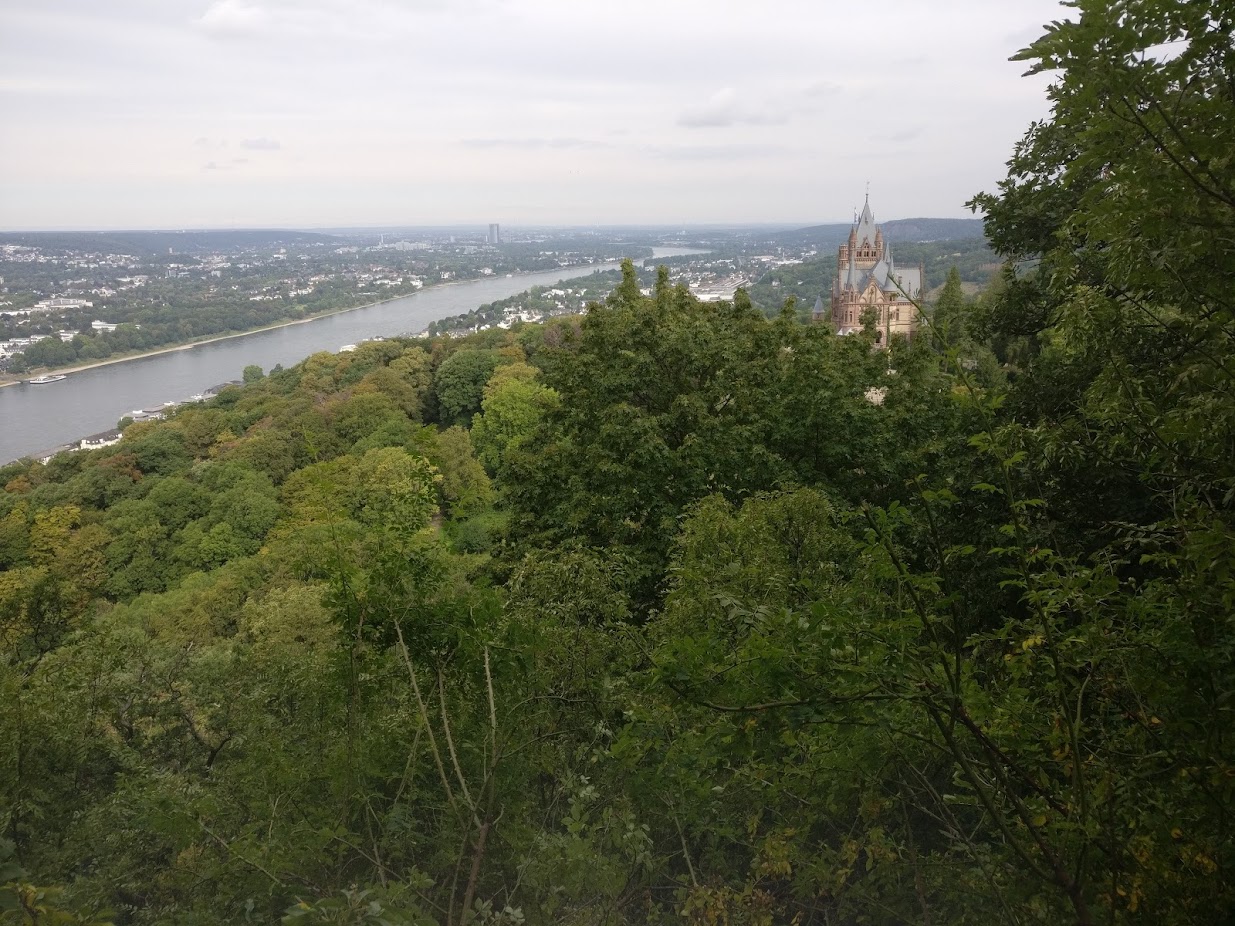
[498,265,918,611]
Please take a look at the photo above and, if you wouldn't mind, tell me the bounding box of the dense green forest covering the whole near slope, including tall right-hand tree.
[0,0,1235,926]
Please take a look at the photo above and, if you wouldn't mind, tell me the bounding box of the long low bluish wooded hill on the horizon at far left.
[0,228,338,256]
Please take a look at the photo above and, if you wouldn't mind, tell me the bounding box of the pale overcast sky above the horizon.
[0,0,1067,230]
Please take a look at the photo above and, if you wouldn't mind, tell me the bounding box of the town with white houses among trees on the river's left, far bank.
[0,226,651,379]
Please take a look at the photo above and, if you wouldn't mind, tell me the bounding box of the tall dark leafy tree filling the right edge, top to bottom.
[953,0,1235,922]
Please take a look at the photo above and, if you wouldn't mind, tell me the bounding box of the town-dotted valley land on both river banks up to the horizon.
[0,220,993,372]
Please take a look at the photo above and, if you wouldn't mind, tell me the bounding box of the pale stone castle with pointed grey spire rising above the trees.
[814,194,924,347]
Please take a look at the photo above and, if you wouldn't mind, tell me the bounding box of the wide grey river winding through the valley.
[0,248,700,464]
